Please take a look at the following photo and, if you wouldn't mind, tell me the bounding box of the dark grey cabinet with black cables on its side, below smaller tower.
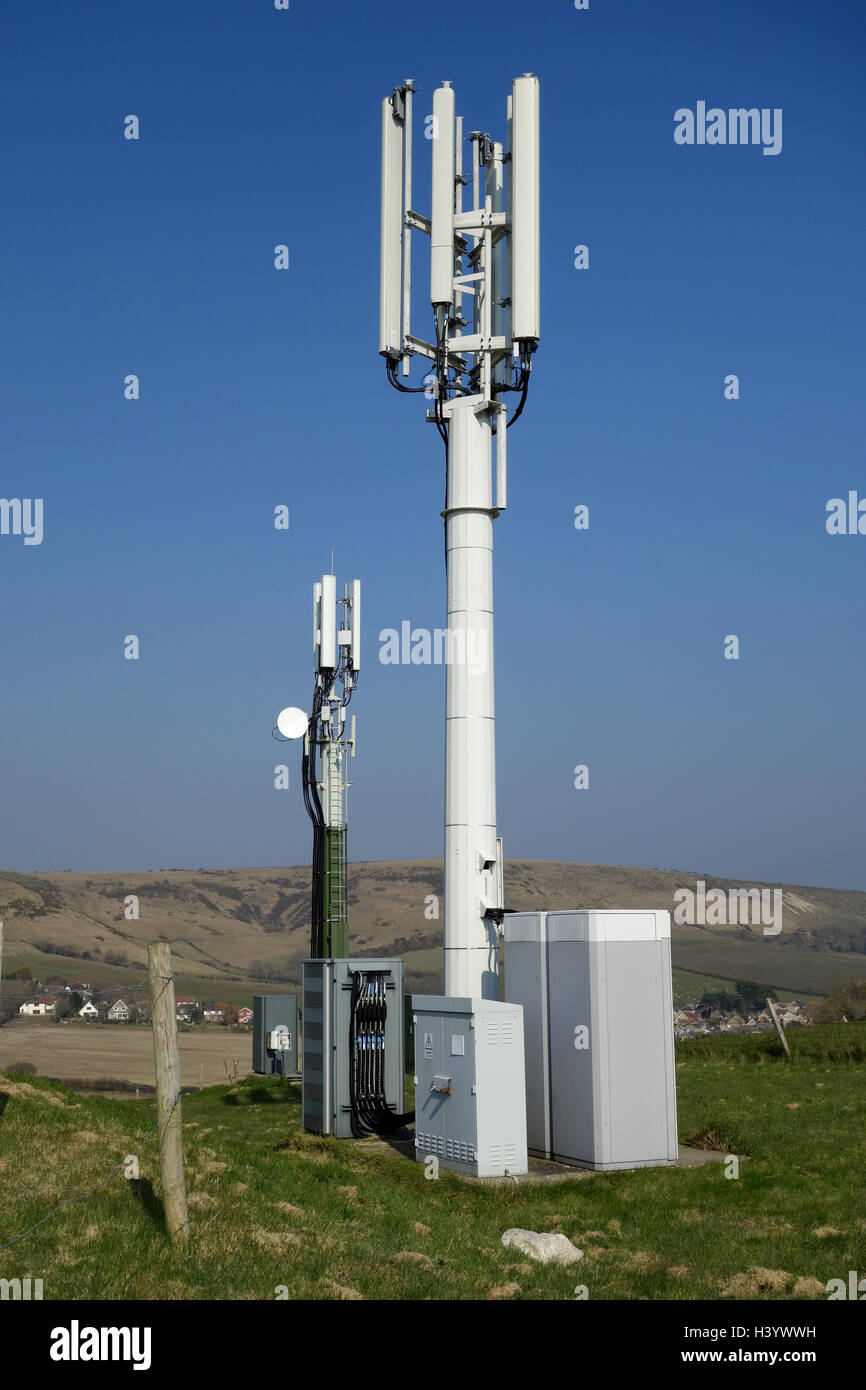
[302,958,406,1138]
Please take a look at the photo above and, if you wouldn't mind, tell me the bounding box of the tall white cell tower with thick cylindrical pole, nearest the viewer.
[379,74,539,999]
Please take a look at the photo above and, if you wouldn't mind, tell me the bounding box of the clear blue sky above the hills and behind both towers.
[0,0,866,888]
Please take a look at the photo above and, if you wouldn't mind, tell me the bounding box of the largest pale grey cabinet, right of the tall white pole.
[505,909,677,1169]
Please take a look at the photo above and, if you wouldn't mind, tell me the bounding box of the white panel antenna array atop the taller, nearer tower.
[379,74,539,428]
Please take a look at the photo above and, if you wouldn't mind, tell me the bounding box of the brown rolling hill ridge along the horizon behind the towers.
[0,859,866,1002]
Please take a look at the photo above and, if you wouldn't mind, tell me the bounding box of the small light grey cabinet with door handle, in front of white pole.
[411,994,527,1177]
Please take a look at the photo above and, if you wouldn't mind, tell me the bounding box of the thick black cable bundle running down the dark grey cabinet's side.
[349,970,414,1138]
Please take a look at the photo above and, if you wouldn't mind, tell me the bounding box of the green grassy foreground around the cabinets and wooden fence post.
[0,1024,866,1300]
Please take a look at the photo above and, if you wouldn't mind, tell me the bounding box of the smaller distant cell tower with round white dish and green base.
[277,574,361,958]
